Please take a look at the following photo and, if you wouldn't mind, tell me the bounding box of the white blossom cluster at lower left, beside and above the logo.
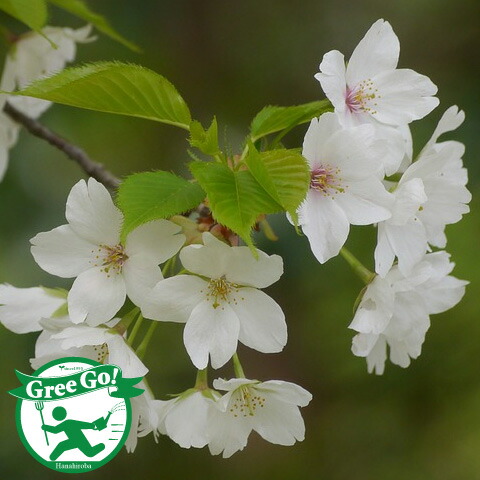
[0,178,311,457]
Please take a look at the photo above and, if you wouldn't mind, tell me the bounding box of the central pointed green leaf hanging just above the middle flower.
[189,162,282,247]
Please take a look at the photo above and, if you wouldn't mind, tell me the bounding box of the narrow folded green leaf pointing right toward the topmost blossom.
[250,100,333,142]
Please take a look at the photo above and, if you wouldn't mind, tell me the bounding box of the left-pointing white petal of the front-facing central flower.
[140,275,208,323]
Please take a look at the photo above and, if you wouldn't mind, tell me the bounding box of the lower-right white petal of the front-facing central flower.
[230,288,287,353]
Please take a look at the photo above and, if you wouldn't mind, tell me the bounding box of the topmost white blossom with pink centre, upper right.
[315,19,439,126]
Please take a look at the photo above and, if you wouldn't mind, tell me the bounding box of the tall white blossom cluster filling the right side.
[298,20,471,374]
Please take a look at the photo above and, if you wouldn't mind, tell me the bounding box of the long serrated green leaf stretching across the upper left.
[7,62,191,130]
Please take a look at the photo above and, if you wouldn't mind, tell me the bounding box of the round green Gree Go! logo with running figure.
[9,357,142,473]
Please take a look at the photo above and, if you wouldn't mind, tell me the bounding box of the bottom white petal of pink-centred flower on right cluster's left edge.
[300,191,350,263]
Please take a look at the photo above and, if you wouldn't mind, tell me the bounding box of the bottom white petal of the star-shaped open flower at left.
[68,267,126,326]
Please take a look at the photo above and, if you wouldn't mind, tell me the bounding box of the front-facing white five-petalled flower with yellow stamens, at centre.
[141,233,287,369]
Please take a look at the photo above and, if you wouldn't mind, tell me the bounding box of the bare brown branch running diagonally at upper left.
[3,103,120,190]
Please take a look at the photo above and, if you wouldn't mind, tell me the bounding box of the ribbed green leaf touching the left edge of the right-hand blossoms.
[245,144,310,221]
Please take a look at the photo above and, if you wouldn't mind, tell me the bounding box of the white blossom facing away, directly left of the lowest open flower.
[156,388,220,448]
